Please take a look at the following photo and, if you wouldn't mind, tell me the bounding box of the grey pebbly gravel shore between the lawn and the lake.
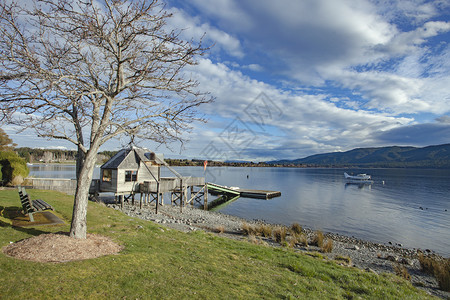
[107,203,450,299]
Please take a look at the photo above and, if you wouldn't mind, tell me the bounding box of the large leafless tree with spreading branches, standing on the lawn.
[0,0,212,238]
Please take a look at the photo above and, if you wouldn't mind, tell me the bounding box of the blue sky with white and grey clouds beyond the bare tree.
[8,0,450,161]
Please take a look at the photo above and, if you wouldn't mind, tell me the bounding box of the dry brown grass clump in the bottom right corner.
[419,254,450,292]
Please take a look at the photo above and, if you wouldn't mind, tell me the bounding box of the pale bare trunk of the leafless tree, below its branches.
[70,147,98,239]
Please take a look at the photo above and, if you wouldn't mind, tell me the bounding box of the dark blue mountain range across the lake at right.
[268,144,450,168]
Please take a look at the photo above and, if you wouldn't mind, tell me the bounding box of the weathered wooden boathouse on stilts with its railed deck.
[89,147,208,209]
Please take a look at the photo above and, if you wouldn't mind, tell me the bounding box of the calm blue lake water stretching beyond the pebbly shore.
[30,165,450,257]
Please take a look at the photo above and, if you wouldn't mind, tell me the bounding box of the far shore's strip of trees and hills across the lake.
[15,144,450,168]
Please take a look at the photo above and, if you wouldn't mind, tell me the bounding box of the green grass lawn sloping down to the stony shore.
[0,190,436,299]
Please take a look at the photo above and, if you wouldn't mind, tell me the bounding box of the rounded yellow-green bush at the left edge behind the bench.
[0,151,30,184]
